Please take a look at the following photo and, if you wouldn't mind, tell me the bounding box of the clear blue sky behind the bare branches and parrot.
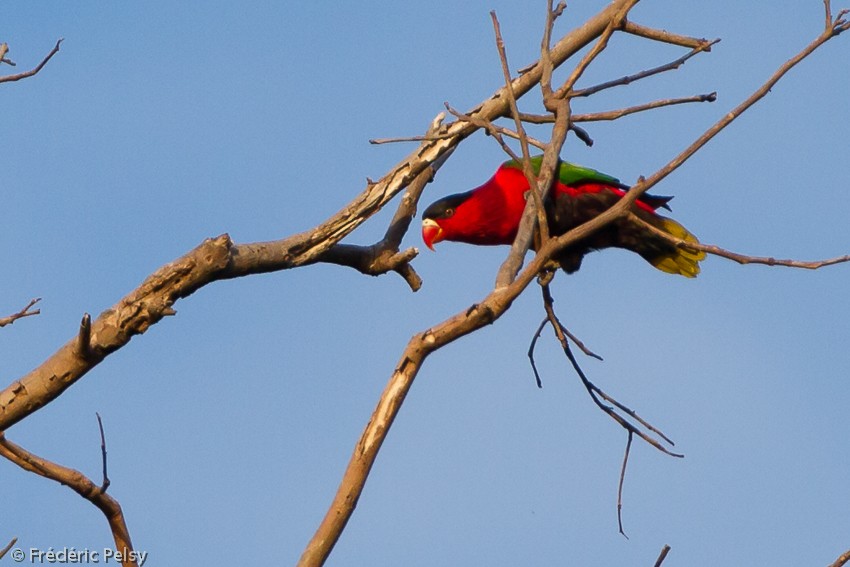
[0,0,850,566]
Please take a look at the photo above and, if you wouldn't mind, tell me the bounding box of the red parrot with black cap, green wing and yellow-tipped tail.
[422,156,705,278]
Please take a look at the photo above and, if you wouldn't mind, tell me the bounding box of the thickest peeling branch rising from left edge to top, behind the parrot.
[0,0,644,431]
